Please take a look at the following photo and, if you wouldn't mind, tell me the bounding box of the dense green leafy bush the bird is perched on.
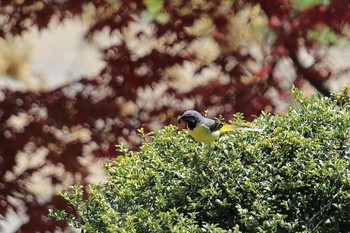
[51,87,350,232]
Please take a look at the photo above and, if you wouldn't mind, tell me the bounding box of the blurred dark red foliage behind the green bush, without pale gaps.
[0,0,350,232]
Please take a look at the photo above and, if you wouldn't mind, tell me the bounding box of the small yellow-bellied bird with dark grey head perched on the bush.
[177,110,263,143]
